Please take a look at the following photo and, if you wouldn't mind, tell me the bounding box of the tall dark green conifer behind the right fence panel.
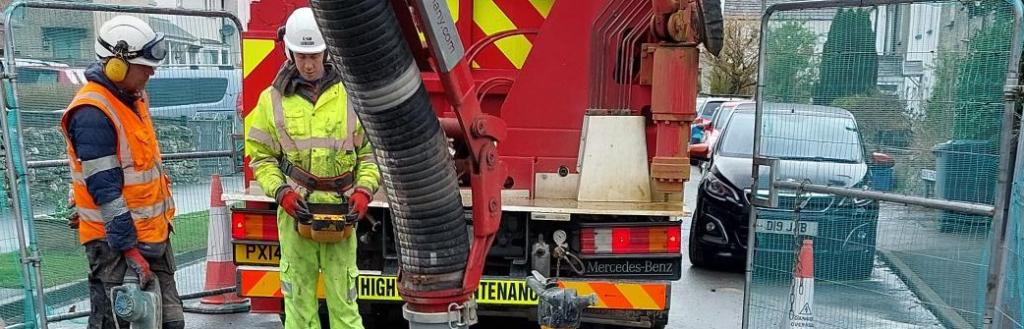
[814,9,879,106]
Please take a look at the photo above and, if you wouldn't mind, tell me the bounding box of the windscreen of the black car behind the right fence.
[718,112,863,163]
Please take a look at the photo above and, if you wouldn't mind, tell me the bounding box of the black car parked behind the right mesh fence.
[689,104,879,279]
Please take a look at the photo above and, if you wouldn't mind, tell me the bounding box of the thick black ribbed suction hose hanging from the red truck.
[310,0,469,292]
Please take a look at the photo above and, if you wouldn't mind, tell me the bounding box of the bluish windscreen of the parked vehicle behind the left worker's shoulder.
[145,78,227,108]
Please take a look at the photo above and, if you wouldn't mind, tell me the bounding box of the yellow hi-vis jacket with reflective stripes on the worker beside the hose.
[245,83,380,203]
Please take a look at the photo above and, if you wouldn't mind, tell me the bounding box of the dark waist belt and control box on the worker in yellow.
[281,160,358,243]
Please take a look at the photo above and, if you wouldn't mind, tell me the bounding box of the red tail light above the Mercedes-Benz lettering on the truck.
[580,224,682,254]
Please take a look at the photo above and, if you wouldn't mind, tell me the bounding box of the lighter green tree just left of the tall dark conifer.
[761,22,817,102]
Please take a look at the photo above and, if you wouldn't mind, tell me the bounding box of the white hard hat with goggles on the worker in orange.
[95,15,167,68]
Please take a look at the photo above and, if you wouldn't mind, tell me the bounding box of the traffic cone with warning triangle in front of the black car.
[786,240,814,329]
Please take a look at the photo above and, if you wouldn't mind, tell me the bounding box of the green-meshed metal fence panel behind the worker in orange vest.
[0,2,242,324]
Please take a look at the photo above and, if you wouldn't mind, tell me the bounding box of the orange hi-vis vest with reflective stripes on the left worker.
[60,82,174,244]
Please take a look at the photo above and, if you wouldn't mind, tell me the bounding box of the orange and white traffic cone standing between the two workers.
[185,174,249,314]
